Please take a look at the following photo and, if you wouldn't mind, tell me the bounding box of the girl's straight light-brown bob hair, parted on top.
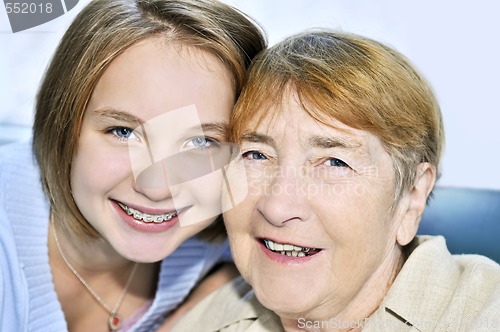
[33,0,266,238]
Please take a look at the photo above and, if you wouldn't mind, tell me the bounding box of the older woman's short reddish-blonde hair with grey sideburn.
[230,29,444,200]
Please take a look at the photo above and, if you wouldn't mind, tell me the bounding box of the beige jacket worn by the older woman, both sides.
[173,236,500,332]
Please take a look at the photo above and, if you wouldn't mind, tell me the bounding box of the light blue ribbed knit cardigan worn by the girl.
[0,141,231,332]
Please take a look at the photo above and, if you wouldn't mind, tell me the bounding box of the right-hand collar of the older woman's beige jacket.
[366,236,460,331]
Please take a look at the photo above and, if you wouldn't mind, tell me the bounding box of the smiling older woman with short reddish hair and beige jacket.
[173,31,500,331]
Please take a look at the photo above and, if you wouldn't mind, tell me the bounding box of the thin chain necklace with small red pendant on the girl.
[50,213,138,331]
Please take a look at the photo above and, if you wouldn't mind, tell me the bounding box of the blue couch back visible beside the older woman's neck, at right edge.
[418,187,500,263]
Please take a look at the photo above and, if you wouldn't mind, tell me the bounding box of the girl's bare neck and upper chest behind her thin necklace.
[48,215,160,331]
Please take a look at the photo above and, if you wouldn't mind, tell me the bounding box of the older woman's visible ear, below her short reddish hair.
[396,162,437,246]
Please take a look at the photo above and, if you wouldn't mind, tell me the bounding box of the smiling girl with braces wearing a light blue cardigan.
[0,0,266,331]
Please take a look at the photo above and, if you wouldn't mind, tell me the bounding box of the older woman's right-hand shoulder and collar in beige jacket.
[372,236,500,331]
